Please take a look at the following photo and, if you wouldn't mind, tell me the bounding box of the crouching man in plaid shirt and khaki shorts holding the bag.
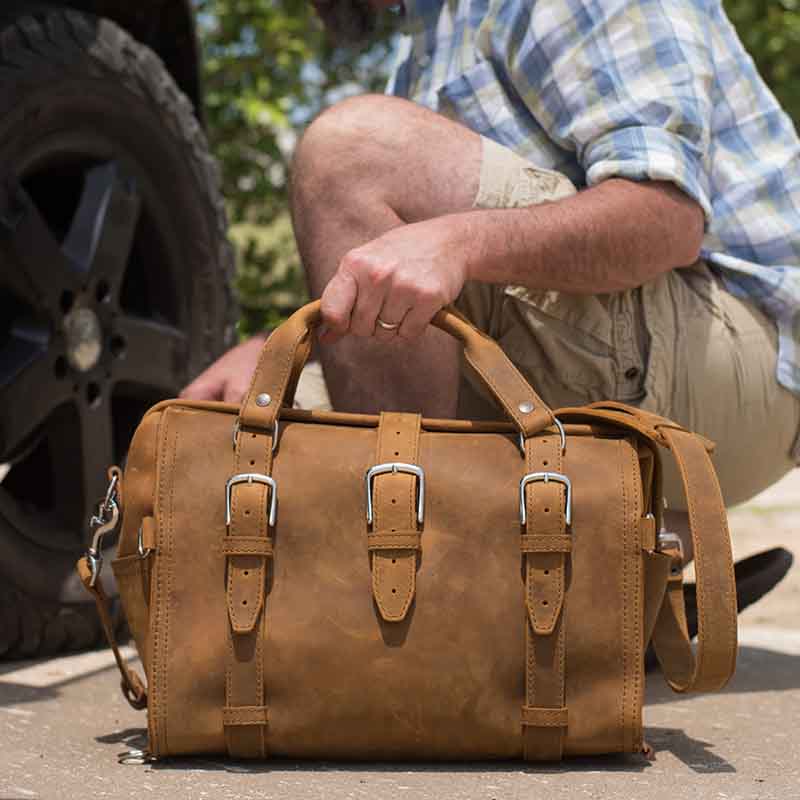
[184,0,800,576]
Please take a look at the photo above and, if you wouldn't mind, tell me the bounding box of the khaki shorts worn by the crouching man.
[456,139,800,509]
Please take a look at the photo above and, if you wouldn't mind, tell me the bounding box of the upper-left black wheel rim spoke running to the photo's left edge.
[0,181,80,308]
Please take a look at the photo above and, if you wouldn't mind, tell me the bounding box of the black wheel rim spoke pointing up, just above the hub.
[62,161,140,292]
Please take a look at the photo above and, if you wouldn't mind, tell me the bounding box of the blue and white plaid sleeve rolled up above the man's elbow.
[511,0,714,226]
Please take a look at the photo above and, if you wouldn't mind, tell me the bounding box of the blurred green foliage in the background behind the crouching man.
[194,0,800,334]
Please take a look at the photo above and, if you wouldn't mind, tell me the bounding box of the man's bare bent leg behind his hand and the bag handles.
[291,96,481,417]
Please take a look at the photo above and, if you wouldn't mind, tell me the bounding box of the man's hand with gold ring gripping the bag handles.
[321,214,474,343]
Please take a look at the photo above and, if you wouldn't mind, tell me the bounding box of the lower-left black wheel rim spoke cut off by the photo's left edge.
[0,338,71,457]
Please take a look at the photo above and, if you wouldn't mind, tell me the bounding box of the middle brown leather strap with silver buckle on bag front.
[366,412,425,622]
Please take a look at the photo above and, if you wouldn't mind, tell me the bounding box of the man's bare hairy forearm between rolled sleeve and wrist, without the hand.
[456,179,703,294]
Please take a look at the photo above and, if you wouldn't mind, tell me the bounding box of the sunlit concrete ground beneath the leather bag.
[0,470,800,800]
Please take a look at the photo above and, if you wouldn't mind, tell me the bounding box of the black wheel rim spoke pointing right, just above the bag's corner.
[112,315,189,394]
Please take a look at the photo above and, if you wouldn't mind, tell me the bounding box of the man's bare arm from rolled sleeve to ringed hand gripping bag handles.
[322,179,704,342]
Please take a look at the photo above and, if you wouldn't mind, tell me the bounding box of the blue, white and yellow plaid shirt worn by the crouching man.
[388,0,800,393]
